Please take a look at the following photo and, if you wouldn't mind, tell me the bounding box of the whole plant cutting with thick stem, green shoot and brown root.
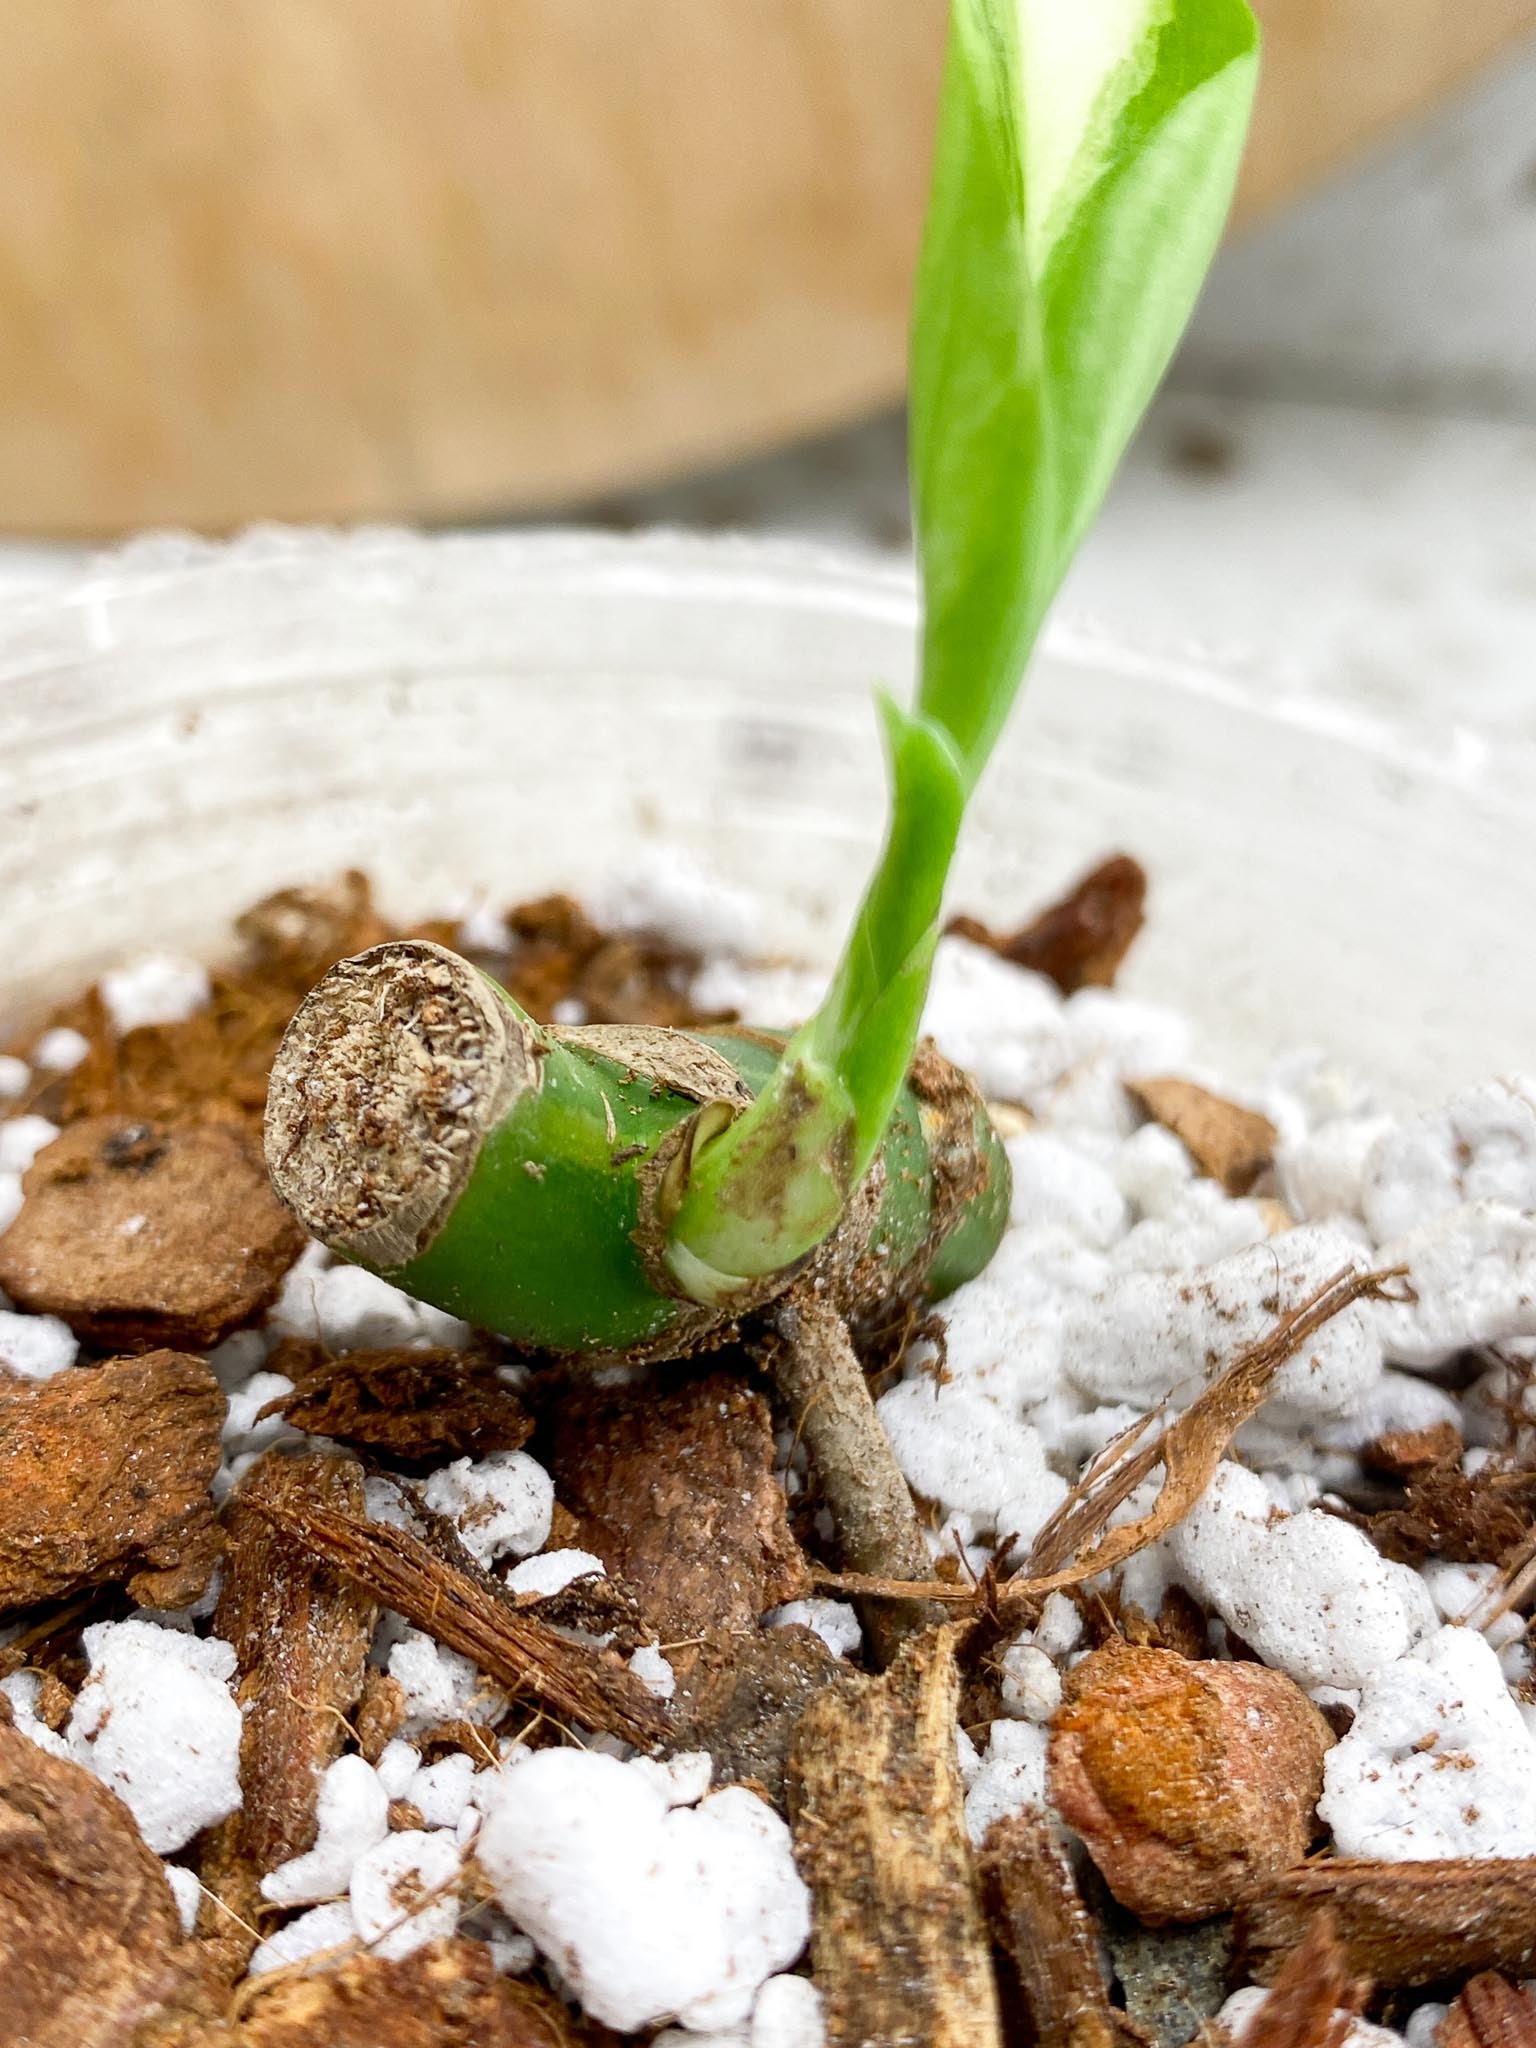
[266,0,1257,1605]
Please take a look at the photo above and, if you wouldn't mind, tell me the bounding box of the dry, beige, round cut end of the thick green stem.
[266,940,539,1272]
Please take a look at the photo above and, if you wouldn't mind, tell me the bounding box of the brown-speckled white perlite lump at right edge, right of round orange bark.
[1317,1628,1536,1862]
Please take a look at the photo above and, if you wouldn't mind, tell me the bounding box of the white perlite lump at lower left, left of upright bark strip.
[63,1620,240,1855]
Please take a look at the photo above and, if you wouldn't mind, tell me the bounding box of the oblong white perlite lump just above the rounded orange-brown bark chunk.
[1167,1462,1436,1690]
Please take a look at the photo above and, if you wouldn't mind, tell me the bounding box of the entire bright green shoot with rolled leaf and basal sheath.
[670,0,1257,1300]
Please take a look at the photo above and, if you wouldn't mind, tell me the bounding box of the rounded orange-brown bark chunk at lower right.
[1051,1642,1333,1927]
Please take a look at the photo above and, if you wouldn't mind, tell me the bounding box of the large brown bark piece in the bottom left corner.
[0,1726,197,2048]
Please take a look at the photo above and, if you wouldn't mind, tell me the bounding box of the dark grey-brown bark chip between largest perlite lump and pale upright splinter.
[672,1628,848,1810]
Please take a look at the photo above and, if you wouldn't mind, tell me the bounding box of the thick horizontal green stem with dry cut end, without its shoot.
[268,942,1008,1358]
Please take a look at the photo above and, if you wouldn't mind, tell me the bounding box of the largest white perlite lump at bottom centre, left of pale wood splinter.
[475,1749,811,2032]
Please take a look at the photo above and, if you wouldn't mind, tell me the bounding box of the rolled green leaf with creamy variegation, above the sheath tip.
[909,0,1257,780]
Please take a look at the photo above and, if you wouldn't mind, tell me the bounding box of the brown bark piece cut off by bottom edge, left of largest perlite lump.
[221,1939,592,2048]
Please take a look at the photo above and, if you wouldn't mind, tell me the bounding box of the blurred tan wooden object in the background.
[0,0,1536,535]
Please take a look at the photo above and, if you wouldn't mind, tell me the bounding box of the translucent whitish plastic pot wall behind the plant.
[0,532,1536,1098]
